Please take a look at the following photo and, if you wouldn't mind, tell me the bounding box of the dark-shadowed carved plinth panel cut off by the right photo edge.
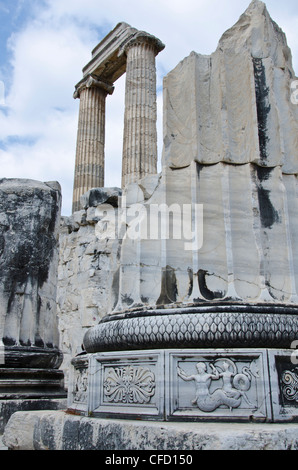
[268,350,298,422]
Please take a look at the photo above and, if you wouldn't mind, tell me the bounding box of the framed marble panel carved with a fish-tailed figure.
[166,349,271,421]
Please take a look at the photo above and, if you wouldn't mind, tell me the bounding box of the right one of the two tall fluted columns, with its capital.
[122,32,165,187]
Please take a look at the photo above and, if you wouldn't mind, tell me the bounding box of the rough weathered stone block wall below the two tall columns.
[57,189,118,382]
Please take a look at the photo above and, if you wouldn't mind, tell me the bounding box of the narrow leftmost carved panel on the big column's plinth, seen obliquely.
[68,354,89,414]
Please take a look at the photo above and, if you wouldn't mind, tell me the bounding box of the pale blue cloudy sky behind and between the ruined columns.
[0,0,298,215]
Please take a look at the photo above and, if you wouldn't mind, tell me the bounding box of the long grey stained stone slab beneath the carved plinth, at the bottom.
[3,411,298,452]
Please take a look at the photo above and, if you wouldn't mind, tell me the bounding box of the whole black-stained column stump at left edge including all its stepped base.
[0,178,67,434]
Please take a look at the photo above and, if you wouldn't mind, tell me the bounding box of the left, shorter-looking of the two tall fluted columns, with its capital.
[72,75,114,212]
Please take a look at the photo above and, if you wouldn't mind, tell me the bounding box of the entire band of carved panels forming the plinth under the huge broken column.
[68,349,298,422]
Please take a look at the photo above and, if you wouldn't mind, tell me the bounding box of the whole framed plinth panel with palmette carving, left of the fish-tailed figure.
[88,351,164,419]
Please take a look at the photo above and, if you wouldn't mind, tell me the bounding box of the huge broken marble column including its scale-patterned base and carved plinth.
[64,2,298,421]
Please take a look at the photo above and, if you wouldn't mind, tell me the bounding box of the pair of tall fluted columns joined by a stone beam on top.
[73,23,165,211]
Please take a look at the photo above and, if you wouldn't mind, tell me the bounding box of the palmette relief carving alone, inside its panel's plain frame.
[103,366,155,404]
